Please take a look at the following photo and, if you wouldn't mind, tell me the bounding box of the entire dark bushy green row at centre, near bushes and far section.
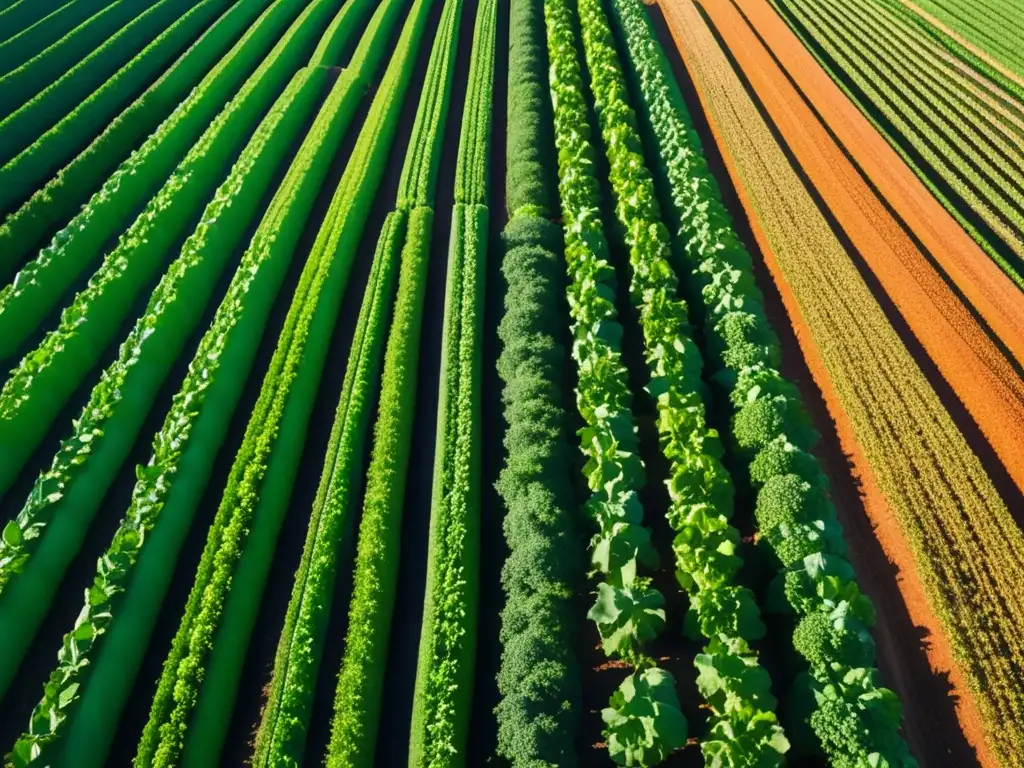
[496,0,583,768]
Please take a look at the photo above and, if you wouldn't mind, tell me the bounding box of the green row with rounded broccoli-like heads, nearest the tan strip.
[612,0,915,768]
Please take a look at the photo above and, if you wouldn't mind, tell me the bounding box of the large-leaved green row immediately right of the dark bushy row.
[544,0,687,765]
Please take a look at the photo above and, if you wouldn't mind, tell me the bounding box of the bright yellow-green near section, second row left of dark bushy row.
[327,207,434,768]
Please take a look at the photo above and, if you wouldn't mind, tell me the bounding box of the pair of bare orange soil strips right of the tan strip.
[706,0,1024,499]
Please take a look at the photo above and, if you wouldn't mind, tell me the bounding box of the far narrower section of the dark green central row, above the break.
[505,0,559,220]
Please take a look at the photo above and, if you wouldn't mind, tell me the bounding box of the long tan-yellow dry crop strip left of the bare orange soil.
[663,1,1024,765]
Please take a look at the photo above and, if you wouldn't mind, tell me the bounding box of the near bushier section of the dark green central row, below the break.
[497,211,583,766]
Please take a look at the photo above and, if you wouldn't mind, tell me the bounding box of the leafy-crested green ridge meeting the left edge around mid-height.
[0,0,344,499]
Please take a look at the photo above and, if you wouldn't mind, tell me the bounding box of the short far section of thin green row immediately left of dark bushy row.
[455,0,498,205]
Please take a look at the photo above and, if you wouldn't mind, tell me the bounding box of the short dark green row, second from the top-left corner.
[0,0,165,118]
